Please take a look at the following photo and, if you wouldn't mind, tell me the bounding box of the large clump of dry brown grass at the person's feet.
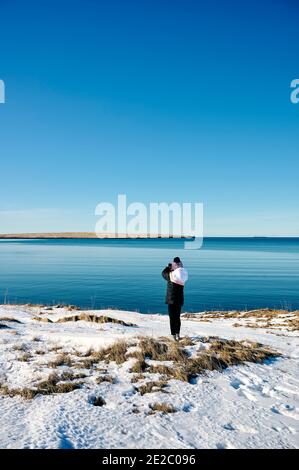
[50,336,280,388]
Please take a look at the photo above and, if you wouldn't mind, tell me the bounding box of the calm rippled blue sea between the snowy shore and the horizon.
[0,238,299,313]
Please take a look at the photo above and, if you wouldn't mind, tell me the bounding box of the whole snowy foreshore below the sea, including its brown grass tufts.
[0,305,299,448]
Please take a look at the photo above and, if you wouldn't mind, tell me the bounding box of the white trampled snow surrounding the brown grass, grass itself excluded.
[0,305,299,448]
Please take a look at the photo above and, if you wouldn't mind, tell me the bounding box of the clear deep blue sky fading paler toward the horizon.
[0,0,299,236]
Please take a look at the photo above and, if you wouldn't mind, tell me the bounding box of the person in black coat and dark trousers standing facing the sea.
[162,256,188,341]
